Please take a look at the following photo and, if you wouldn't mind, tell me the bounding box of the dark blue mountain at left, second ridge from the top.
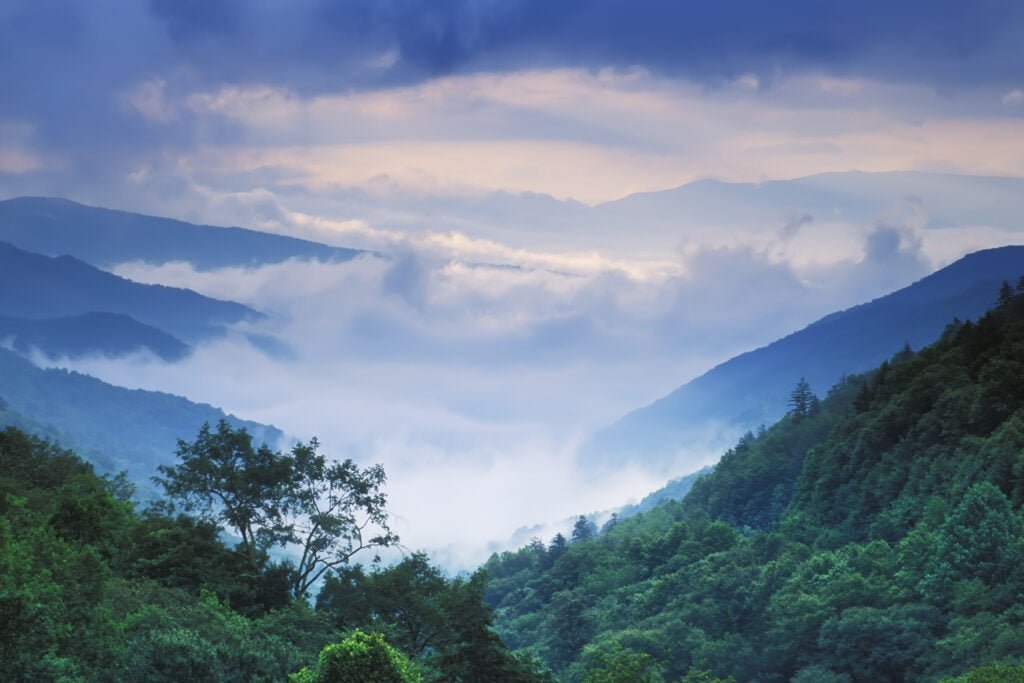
[0,243,263,342]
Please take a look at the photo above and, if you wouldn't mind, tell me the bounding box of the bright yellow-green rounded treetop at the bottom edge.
[289,630,421,683]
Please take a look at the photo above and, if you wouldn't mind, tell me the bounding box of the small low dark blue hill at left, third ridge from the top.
[0,312,189,361]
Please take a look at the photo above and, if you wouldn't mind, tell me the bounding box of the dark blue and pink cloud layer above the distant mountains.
[0,0,1024,208]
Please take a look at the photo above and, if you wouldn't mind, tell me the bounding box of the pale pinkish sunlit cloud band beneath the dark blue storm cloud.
[116,69,1024,203]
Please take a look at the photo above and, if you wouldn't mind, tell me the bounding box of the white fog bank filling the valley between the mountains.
[39,205,958,567]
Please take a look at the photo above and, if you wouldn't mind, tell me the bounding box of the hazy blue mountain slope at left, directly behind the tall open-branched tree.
[0,348,284,483]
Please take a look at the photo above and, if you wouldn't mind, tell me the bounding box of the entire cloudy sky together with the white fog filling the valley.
[0,0,1024,566]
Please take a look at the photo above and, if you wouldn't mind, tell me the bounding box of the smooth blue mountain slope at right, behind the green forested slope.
[583,247,1024,466]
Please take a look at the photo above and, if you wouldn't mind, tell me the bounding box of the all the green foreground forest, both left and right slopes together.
[6,288,1024,683]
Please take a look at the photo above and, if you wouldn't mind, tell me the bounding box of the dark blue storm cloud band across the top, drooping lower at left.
[0,0,1024,192]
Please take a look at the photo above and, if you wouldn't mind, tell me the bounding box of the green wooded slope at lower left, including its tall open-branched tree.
[0,424,546,683]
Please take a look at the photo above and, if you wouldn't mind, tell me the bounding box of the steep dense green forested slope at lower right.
[485,289,1024,683]
